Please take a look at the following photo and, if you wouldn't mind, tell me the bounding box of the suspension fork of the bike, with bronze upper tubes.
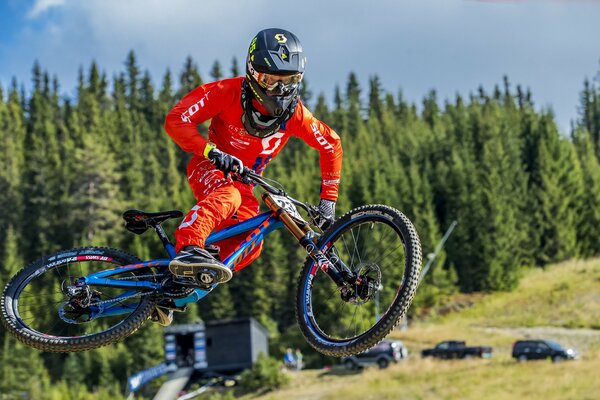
[262,193,352,288]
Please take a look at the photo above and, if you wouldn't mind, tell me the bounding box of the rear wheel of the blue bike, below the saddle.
[1,247,152,352]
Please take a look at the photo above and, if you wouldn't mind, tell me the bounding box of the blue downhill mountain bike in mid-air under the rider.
[0,169,421,356]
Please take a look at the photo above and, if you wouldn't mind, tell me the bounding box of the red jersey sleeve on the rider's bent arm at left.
[165,81,239,156]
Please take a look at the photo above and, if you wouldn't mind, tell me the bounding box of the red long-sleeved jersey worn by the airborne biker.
[165,77,342,201]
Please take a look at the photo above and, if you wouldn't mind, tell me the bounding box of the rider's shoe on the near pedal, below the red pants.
[169,246,233,286]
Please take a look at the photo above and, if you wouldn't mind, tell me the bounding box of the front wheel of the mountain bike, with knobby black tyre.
[296,205,422,357]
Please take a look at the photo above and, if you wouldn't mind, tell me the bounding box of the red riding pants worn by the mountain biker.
[175,156,262,271]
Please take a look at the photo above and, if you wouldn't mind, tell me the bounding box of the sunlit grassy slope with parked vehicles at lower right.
[240,259,600,400]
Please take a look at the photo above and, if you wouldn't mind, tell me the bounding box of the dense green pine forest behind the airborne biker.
[0,52,600,399]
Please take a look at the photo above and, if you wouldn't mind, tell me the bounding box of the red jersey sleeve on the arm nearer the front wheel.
[292,104,343,201]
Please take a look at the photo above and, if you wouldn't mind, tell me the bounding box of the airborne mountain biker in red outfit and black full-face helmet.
[165,29,342,285]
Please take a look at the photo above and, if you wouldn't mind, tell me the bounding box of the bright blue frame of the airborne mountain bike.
[81,211,284,317]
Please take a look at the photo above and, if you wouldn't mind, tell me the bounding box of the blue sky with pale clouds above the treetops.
[0,0,600,133]
